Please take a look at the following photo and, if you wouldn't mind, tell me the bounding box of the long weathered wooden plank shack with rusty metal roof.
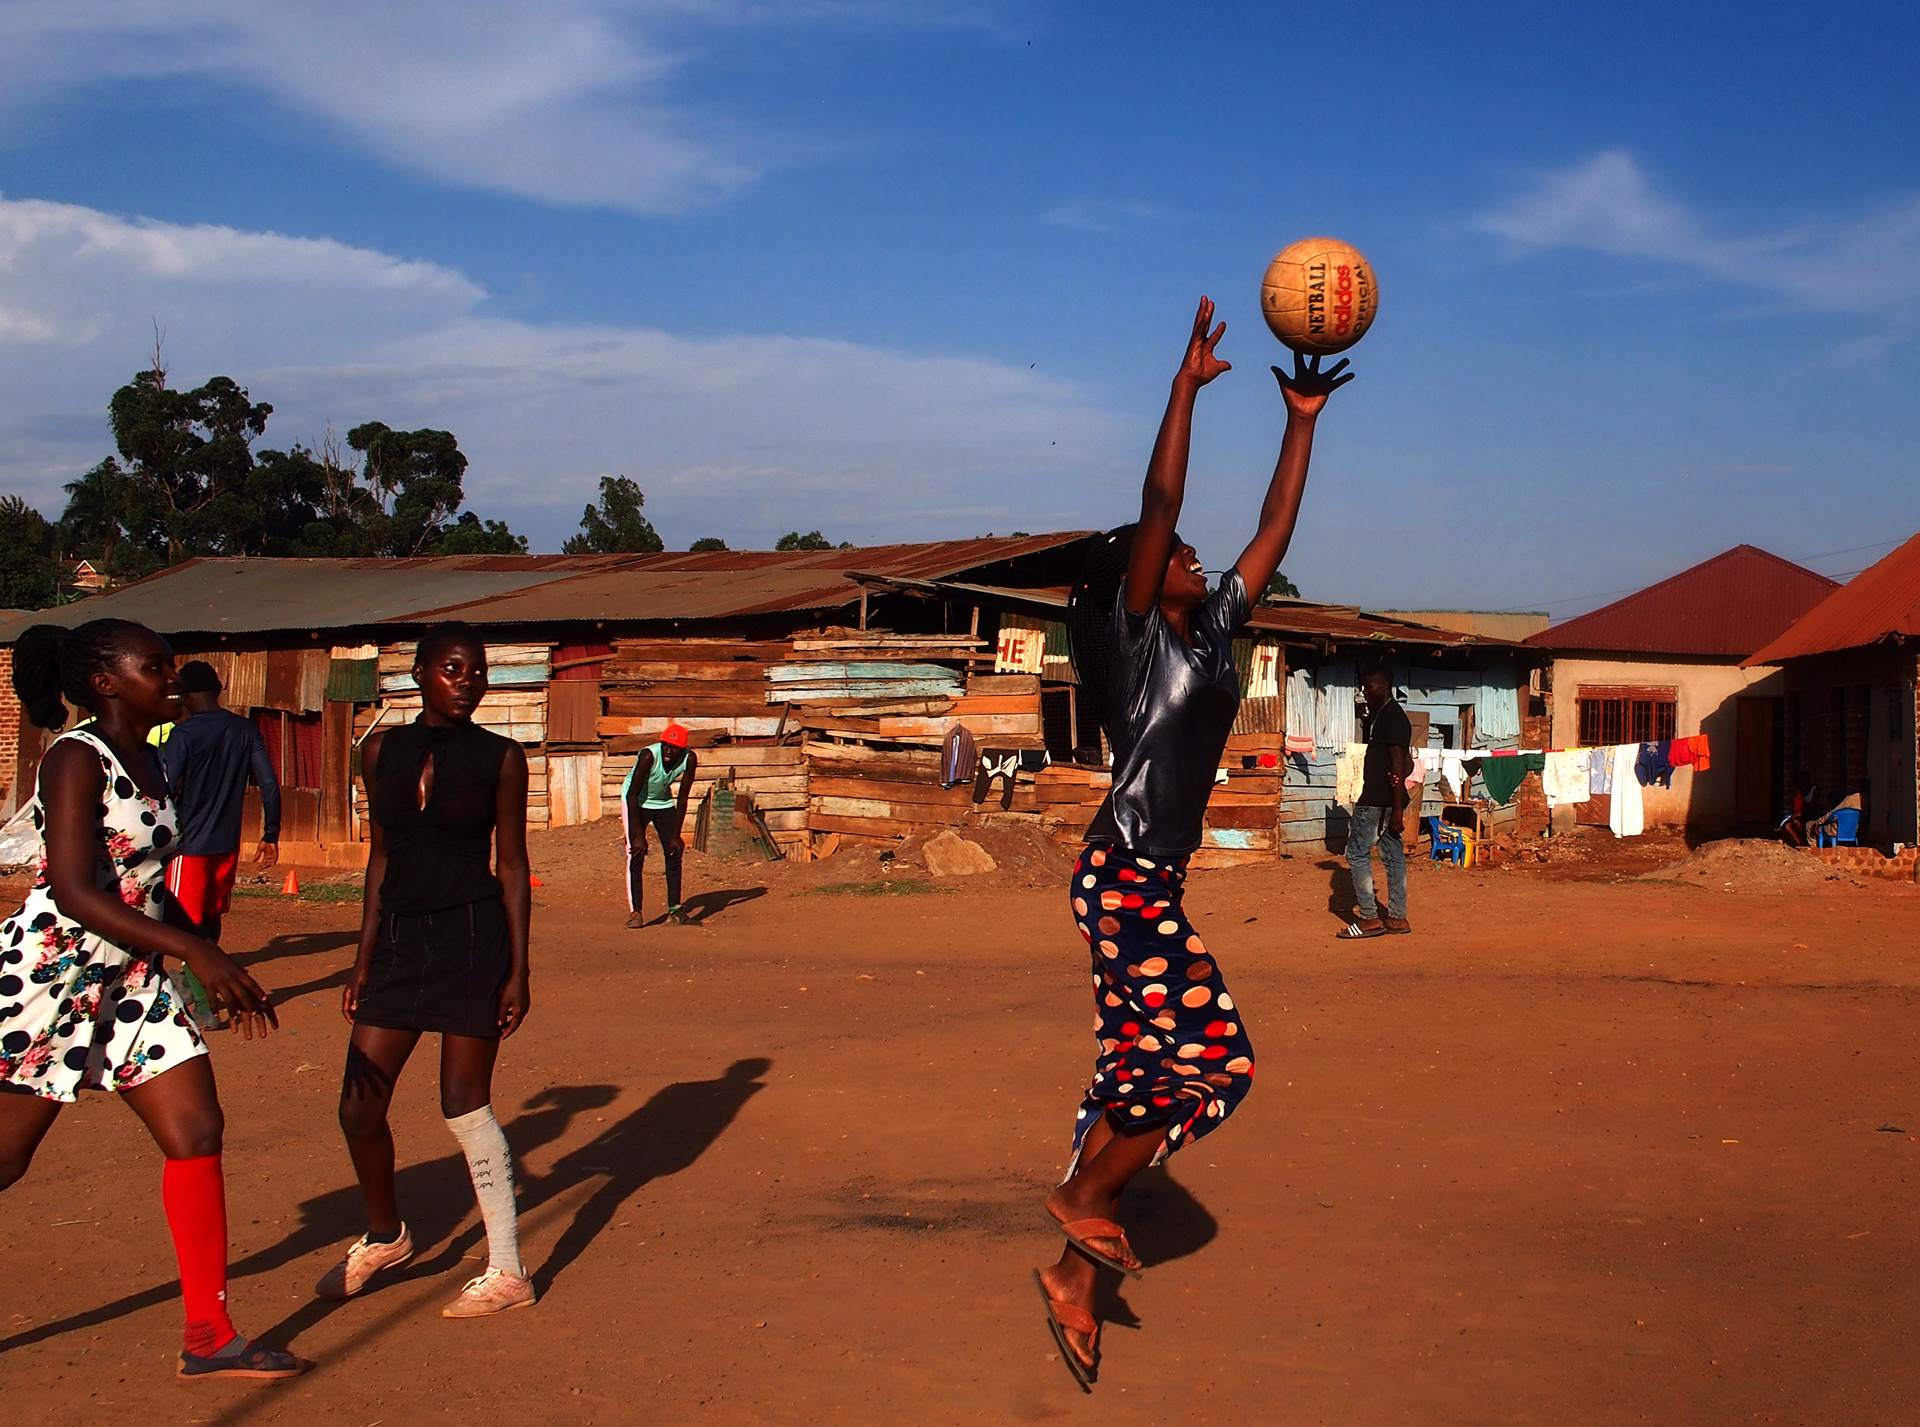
[0,532,1528,866]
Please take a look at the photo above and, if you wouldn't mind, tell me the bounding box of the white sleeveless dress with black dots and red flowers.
[0,730,207,1100]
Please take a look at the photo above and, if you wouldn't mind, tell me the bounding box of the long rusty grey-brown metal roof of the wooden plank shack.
[0,530,1089,643]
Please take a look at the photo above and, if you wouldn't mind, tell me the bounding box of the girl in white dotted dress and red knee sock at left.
[0,618,311,1379]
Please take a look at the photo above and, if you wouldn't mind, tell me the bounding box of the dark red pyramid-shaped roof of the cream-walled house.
[1526,545,1837,659]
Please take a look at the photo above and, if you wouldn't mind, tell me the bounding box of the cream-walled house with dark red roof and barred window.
[1526,545,1837,837]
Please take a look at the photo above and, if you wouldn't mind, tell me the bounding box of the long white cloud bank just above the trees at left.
[0,198,1117,545]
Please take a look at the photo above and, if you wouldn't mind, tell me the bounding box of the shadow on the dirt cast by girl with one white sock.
[520,1056,774,1294]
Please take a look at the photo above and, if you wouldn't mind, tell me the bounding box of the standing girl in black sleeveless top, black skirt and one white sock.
[315,624,534,1318]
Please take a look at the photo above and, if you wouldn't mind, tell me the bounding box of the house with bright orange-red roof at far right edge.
[1745,534,1920,849]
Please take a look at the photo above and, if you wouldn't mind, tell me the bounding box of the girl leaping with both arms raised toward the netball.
[1035,298,1354,1391]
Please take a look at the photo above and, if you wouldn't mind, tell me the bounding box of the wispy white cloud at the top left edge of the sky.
[0,0,985,213]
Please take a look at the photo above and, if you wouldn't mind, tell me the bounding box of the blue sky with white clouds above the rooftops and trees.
[0,0,1920,617]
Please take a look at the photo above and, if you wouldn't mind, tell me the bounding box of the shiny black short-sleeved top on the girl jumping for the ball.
[1087,570,1252,857]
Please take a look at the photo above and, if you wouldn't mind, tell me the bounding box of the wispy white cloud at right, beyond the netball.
[1476,150,1920,325]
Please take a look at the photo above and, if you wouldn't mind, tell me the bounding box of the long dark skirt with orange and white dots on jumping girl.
[1069,847,1254,1162]
